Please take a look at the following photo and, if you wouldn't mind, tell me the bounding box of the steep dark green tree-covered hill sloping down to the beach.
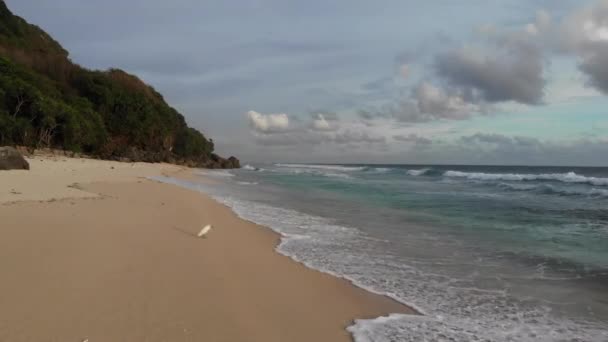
[0,0,239,168]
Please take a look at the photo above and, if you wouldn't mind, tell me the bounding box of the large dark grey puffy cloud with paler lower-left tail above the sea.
[358,11,552,123]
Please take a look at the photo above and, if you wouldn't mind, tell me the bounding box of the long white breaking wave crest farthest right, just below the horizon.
[443,171,608,186]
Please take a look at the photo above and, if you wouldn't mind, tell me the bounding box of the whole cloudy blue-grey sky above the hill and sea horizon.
[6,0,608,165]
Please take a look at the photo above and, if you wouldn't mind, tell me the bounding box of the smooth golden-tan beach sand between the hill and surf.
[0,157,412,342]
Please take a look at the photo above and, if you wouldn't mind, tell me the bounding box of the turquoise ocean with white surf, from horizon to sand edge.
[154,164,608,342]
